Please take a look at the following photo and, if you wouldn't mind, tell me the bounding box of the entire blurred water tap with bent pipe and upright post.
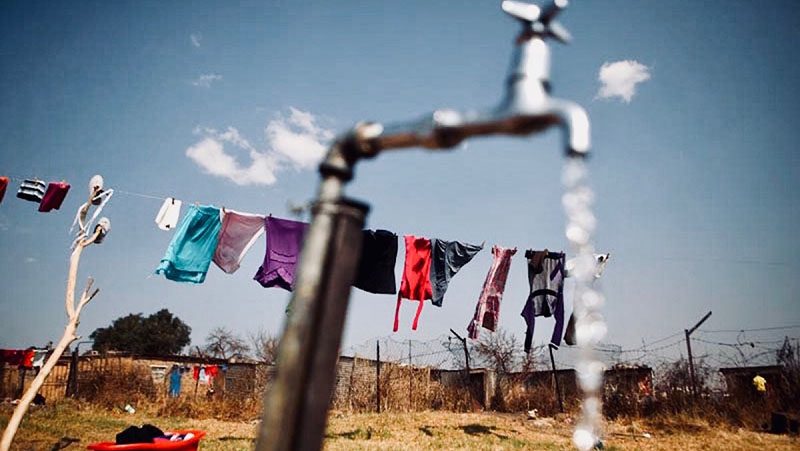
[256,0,590,451]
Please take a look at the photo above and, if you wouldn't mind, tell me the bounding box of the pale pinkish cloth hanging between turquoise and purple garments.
[214,208,264,274]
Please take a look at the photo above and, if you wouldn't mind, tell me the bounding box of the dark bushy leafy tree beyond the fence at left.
[89,309,192,355]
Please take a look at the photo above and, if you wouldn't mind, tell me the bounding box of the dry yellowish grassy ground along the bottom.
[0,403,800,451]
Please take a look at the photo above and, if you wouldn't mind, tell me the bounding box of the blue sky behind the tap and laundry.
[0,0,800,362]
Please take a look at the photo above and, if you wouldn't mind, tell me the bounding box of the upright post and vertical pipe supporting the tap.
[255,188,369,451]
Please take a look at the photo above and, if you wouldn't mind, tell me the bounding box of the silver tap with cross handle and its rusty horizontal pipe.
[320,0,591,191]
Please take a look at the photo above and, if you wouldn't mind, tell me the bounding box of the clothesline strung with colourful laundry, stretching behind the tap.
[3,171,608,344]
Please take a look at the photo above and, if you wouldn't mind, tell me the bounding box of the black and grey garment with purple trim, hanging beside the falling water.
[521,249,565,352]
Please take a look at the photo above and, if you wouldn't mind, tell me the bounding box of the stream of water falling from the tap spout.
[561,157,607,451]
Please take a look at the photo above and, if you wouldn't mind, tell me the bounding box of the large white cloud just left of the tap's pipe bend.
[186,107,333,185]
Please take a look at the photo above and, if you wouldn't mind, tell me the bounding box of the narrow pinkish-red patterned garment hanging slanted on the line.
[467,245,517,340]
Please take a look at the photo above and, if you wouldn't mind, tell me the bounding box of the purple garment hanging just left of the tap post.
[253,216,308,291]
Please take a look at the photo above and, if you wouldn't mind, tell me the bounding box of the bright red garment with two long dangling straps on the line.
[394,235,433,332]
